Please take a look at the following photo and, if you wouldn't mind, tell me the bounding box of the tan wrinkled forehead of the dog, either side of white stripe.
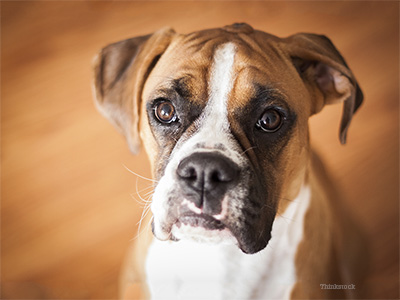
[144,27,304,107]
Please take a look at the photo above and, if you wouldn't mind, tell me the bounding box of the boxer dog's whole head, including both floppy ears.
[94,24,363,253]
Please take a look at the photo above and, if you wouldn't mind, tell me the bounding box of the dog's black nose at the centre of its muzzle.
[177,152,239,215]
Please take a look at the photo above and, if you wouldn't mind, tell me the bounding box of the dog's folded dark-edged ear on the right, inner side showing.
[284,33,363,144]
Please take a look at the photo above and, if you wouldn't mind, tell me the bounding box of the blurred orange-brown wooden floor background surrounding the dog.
[1,1,399,299]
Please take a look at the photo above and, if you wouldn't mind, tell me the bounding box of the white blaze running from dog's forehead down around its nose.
[151,43,243,239]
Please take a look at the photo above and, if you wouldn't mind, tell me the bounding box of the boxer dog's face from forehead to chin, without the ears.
[141,32,311,253]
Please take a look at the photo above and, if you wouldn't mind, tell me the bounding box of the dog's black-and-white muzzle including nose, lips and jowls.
[152,149,275,253]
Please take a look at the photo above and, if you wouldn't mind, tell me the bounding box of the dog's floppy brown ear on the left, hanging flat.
[93,28,175,153]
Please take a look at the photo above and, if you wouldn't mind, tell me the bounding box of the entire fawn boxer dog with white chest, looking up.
[94,24,364,299]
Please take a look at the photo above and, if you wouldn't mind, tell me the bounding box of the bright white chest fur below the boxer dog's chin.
[146,187,310,300]
